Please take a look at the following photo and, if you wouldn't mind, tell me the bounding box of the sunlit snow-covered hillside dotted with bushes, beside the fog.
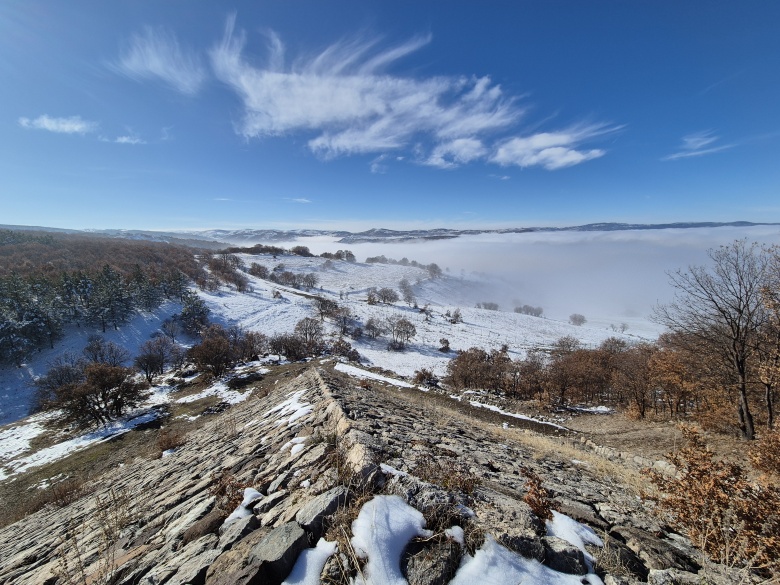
[200,254,637,376]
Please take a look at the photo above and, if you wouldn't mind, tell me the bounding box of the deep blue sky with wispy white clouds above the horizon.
[0,0,780,229]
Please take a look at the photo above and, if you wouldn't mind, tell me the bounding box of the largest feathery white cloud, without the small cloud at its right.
[211,19,521,158]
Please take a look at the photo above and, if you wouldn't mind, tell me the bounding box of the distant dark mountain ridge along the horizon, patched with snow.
[0,221,780,247]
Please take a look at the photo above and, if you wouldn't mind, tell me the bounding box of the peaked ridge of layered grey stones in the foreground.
[0,362,748,585]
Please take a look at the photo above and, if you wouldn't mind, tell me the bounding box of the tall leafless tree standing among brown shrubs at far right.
[654,240,768,439]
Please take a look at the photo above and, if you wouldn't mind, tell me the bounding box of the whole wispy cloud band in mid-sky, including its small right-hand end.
[209,16,617,173]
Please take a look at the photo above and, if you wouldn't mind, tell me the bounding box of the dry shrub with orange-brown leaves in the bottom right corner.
[649,426,780,574]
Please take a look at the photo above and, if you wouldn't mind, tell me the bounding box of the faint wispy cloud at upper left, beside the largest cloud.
[114,27,206,95]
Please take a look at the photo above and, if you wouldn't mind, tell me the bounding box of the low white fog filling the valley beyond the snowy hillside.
[272,226,780,334]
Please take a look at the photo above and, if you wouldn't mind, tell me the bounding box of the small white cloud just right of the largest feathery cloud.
[490,124,621,170]
